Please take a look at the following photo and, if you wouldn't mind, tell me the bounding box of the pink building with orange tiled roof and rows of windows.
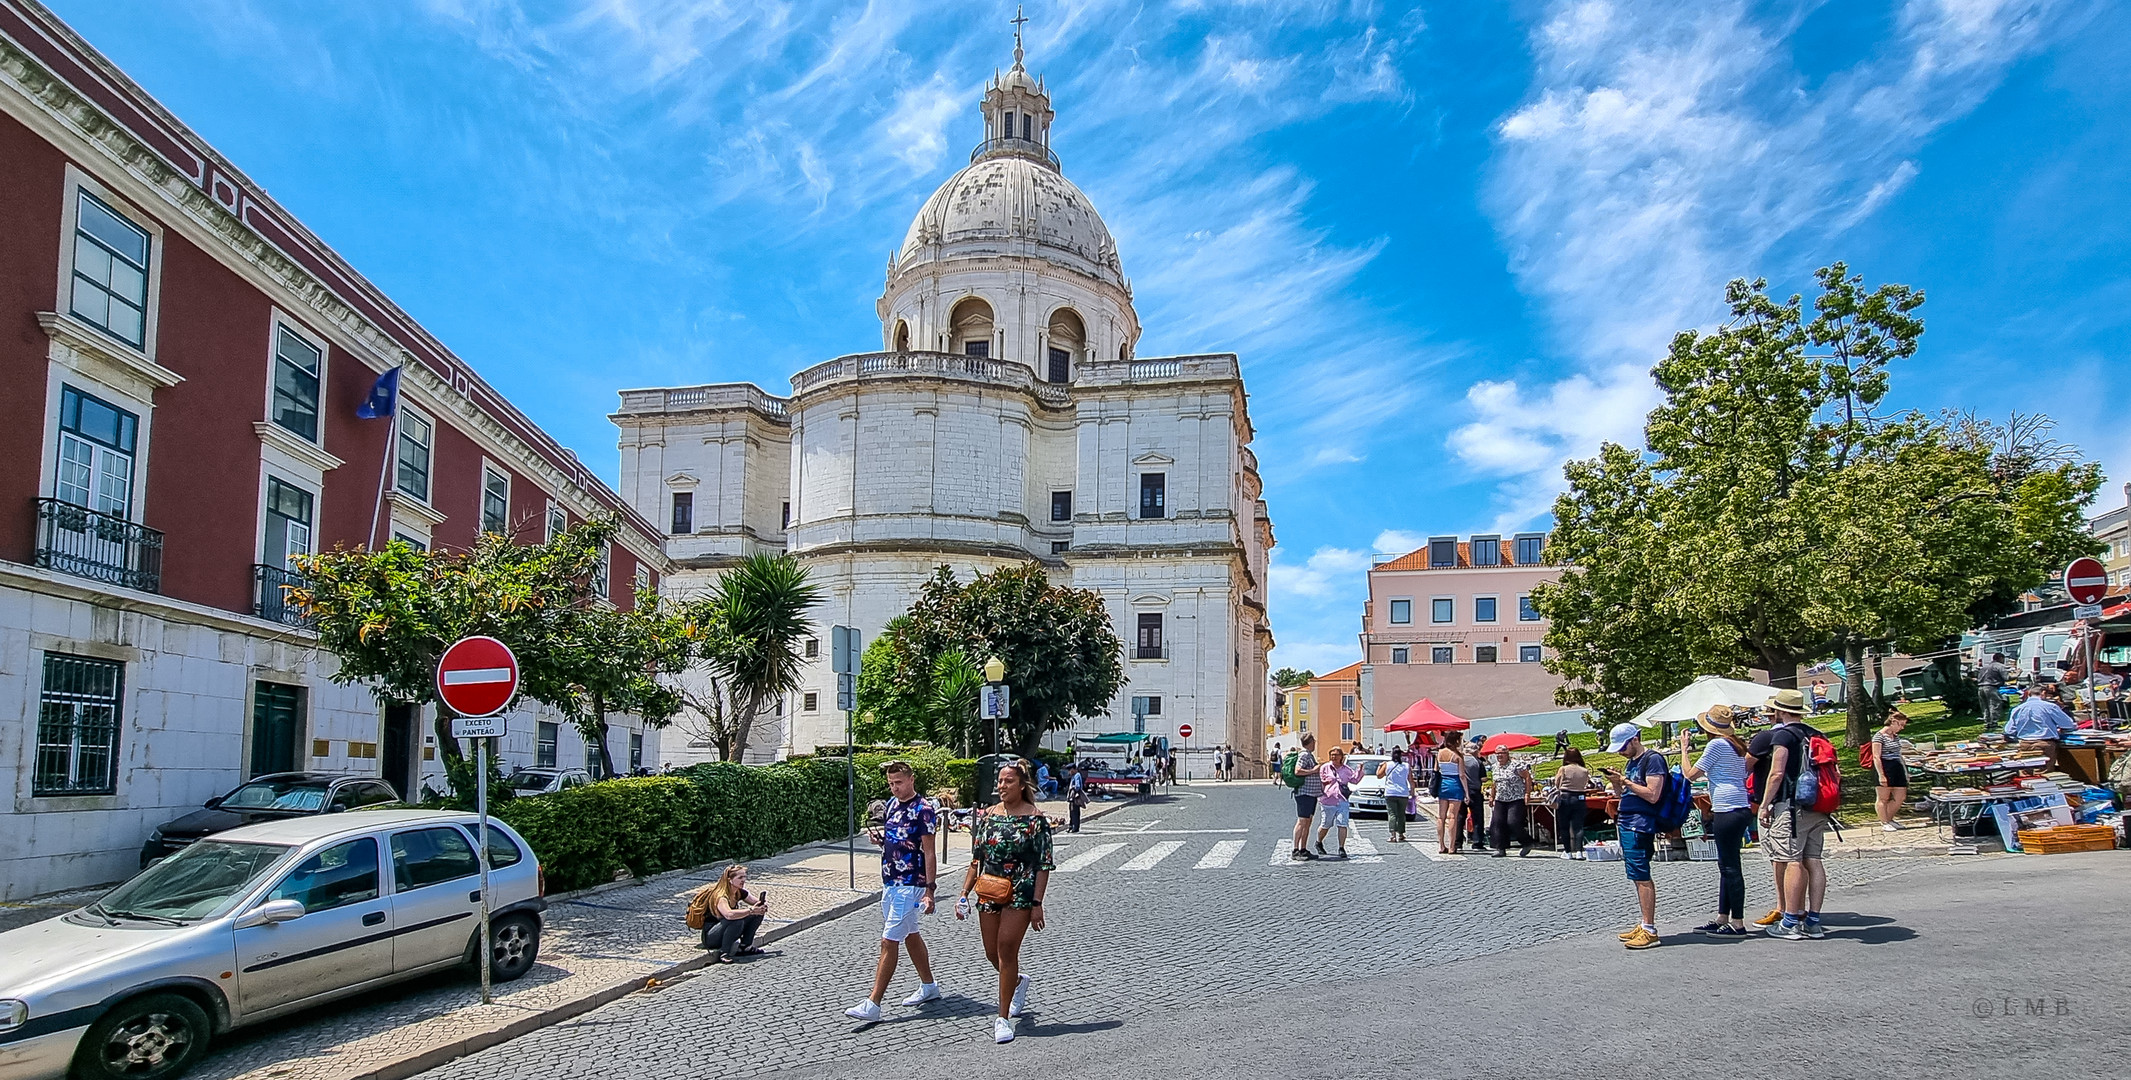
[1360,533,1562,743]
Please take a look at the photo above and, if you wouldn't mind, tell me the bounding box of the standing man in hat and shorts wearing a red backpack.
[1747,690,1841,942]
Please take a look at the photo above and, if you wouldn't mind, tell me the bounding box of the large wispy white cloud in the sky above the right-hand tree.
[1474,0,2069,526]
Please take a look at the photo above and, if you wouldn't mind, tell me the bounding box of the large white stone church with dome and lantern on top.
[614,34,1272,760]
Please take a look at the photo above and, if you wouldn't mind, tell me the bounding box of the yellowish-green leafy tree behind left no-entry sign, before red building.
[288,520,618,775]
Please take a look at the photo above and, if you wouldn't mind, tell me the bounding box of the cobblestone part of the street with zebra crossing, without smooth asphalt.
[411,782,2079,1080]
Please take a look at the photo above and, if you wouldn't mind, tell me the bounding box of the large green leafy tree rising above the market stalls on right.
[1532,264,2099,739]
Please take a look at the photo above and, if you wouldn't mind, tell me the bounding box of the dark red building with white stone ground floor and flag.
[0,0,665,899]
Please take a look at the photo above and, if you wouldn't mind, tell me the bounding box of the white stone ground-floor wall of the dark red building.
[0,564,658,901]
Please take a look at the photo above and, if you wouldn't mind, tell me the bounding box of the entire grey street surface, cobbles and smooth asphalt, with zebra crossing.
[411,782,2131,1080]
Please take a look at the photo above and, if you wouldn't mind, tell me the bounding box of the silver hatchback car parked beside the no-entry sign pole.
[0,809,546,1080]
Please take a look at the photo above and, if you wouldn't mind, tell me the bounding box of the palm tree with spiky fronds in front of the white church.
[699,556,820,760]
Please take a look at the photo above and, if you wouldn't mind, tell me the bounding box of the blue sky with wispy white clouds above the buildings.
[47,0,2131,671]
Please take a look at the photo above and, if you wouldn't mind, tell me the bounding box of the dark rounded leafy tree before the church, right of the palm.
[859,564,1125,754]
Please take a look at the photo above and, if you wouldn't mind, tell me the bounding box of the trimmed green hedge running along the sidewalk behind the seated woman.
[494,748,976,890]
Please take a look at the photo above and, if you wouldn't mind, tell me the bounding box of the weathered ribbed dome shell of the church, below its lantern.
[895,152,1125,288]
